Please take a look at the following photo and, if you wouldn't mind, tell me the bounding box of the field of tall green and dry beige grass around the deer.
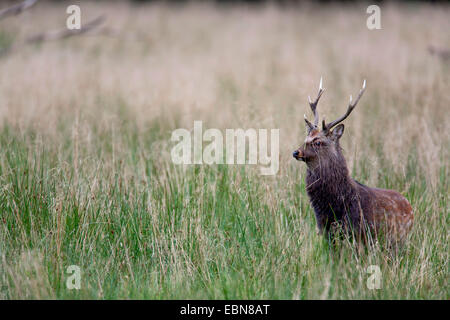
[0,2,450,299]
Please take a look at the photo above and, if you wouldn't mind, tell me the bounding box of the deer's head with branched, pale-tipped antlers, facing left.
[293,78,366,168]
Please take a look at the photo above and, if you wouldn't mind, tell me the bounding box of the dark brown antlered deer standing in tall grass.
[293,78,413,243]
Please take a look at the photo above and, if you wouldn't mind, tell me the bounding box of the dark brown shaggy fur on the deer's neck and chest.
[306,144,360,232]
